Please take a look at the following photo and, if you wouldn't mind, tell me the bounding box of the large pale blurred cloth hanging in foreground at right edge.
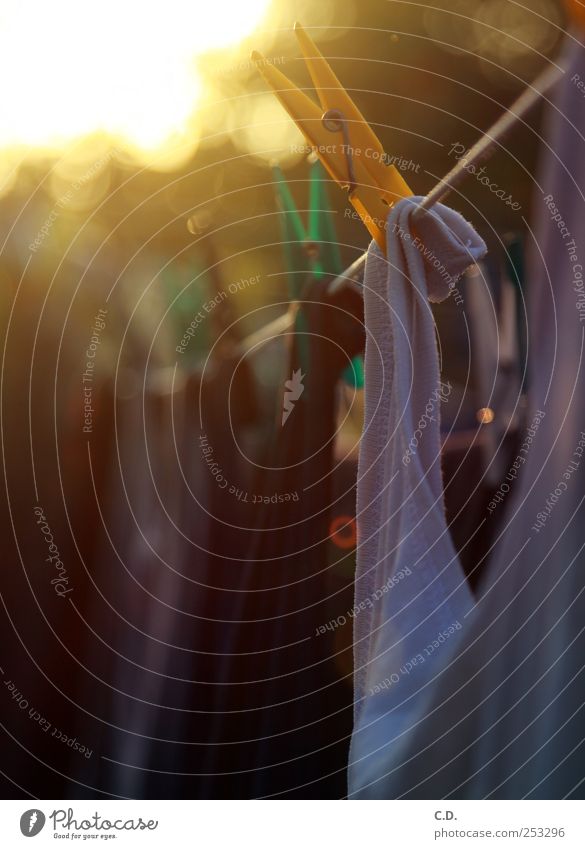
[352,42,585,799]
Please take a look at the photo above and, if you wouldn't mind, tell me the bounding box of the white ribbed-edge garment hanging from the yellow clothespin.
[349,198,485,796]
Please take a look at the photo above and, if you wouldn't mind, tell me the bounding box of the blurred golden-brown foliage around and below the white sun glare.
[0,0,565,380]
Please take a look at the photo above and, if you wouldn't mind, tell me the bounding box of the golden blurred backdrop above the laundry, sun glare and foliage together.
[0,0,565,372]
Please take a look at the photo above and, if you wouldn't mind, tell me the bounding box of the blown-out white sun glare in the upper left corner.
[0,0,270,150]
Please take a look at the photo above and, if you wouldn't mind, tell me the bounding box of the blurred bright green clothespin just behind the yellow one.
[273,160,364,389]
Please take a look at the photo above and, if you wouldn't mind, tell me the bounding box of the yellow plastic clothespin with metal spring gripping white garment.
[252,23,412,253]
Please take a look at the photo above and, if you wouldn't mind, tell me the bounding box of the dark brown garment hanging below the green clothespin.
[194,278,363,798]
